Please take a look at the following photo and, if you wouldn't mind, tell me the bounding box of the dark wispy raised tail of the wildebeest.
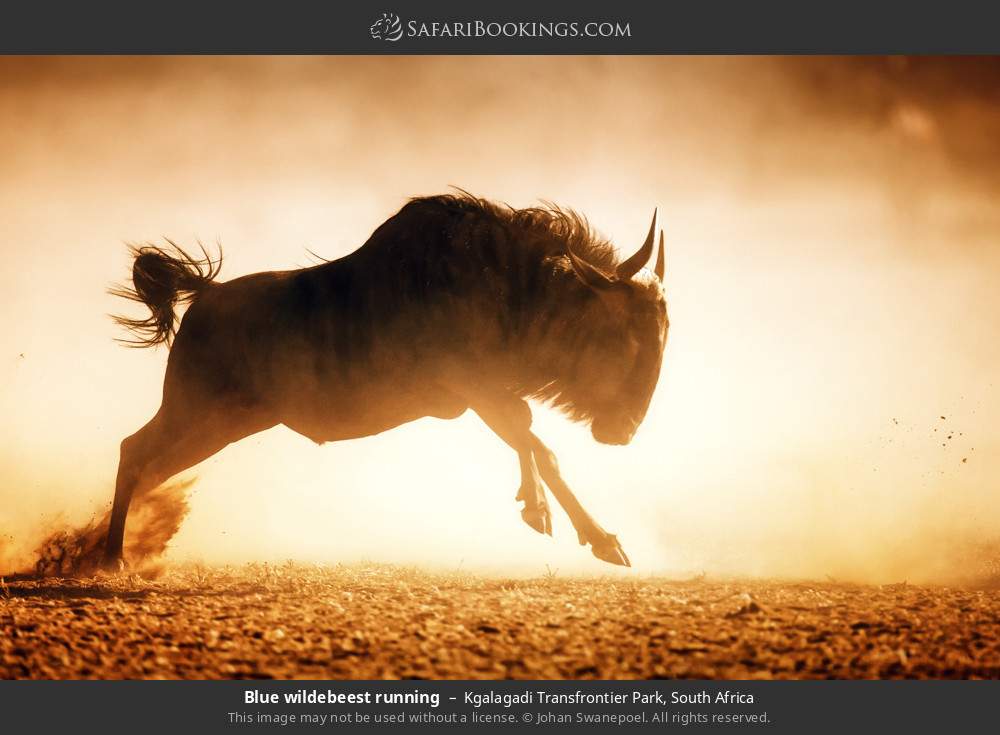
[110,240,222,347]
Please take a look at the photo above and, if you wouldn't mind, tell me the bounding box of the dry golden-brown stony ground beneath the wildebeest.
[0,564,1000,678]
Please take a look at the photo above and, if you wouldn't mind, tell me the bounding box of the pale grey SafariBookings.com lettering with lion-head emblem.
[368,13,632,41]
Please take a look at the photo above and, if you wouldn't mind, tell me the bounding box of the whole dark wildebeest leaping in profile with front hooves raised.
[104,193,668,568]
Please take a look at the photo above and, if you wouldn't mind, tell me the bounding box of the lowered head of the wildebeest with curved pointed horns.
[567,211,670,444]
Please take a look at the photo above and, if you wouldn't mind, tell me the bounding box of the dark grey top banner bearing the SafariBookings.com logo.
[0,0,1000,54]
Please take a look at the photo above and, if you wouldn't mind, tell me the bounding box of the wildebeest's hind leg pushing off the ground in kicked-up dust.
[102,407,275,571]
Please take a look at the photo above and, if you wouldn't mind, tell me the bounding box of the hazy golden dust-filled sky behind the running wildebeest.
[0,57,1000,581]
